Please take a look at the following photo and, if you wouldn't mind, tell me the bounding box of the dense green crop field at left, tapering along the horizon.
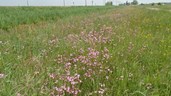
[0,7,111,30]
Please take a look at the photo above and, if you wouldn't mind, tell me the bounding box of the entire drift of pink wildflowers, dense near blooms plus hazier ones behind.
[49,27,112,96]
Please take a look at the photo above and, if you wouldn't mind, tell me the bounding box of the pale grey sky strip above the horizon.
[0,0,171,6]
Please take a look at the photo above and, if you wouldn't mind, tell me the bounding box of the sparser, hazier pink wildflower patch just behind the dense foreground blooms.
[66,25,115,46]
